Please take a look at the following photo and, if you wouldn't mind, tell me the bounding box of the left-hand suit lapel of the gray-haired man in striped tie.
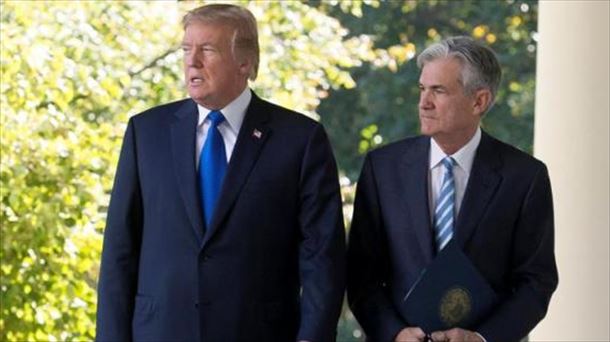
[398,137,434,263]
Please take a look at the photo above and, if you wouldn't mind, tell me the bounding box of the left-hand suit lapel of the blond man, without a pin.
[170,100,203,243]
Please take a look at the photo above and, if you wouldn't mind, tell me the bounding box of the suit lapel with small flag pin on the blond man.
[201,93,271,248]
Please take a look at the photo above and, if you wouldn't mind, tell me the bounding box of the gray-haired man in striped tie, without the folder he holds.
[347,37,558,341]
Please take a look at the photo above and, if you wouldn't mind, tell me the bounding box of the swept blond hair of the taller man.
[182,4,260,81]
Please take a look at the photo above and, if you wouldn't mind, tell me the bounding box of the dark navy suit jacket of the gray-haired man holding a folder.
[347,132,558,342]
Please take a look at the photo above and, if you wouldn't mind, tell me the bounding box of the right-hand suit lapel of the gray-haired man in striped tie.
[455,132,502,248]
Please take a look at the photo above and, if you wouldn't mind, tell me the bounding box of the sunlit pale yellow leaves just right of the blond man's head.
[249,1,374,117]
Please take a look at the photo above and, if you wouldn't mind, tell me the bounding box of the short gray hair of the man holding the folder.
[417,36,502,110]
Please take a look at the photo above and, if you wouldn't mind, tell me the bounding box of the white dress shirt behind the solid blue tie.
[195,87,252,170]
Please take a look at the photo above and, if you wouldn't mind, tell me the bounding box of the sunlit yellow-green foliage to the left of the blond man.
[0,2,181,341]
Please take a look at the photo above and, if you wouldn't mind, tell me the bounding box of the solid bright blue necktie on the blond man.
[199,110,227,228]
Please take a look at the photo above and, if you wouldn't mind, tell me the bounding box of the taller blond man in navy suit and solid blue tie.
[97,5,345,342]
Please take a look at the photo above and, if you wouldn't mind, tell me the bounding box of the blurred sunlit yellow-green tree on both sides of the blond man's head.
[0,1,370,341]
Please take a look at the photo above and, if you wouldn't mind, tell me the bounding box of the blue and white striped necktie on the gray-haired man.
[434,157,455,251]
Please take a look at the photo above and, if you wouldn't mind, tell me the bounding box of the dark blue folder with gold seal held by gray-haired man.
[400,240,497,334]
